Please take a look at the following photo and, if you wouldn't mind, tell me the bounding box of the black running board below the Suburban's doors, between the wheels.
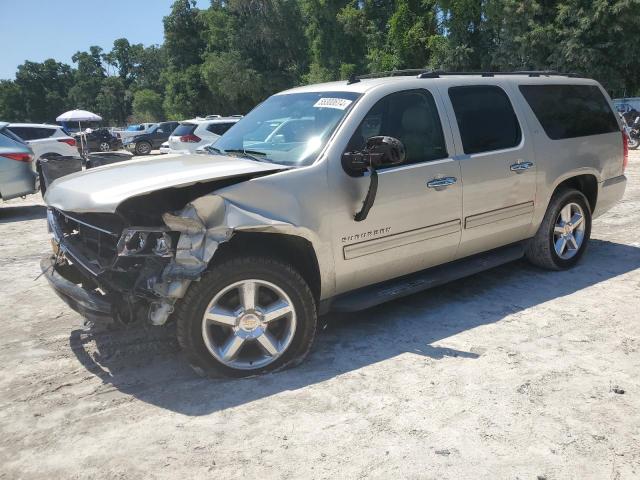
[328,242,524,312]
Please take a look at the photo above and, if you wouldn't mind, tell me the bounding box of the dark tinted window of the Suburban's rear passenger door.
[449,85,522,154]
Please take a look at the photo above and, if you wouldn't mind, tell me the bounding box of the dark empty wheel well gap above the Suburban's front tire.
[212,232,320,301]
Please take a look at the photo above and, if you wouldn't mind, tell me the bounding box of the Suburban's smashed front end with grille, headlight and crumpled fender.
[42,189,316,325]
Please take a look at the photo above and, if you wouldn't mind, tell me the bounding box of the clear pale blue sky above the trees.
[0,0,202,79]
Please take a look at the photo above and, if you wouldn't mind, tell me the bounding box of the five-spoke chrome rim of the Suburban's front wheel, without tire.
[202,279,296,370]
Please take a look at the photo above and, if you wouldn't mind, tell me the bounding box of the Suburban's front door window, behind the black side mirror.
[347,90,448,164]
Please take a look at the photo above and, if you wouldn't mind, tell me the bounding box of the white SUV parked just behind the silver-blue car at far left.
[7,123,79,171]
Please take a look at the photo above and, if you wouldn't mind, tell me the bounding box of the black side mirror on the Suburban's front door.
[342,136,405,177]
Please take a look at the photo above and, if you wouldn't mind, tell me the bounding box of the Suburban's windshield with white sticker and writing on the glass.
[215,92,360,167]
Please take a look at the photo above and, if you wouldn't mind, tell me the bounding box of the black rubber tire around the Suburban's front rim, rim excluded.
[173,256,318,377]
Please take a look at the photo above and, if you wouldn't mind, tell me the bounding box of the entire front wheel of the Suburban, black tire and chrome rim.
[175,257,317,377]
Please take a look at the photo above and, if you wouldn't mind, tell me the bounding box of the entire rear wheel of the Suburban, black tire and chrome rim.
[526,189,591,270]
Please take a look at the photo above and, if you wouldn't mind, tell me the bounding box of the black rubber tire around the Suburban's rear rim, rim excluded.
[525,188,591,270]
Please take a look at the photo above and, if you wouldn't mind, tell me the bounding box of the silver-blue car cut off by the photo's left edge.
[0,122,38,200]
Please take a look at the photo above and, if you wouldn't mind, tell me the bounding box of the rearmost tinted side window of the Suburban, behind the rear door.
[520,85,620,140]
